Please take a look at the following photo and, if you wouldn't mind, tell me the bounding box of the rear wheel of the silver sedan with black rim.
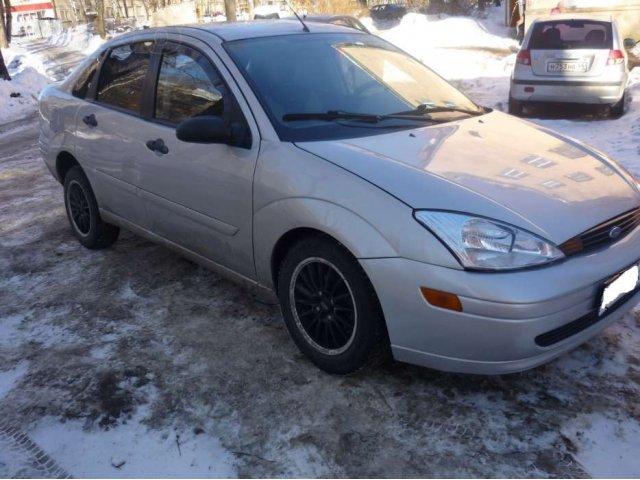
[64,166,120,250]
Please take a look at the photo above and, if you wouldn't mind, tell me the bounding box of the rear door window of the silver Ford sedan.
[96,42,153,114]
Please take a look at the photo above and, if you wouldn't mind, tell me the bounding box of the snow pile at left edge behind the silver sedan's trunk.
[0,67,49,124]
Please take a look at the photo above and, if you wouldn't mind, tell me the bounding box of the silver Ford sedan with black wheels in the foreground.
[40,21,640,374]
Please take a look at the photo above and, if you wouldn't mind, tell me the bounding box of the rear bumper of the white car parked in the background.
[510,79,625,104]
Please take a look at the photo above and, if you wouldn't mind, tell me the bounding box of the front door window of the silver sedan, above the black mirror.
[155,44,224,125]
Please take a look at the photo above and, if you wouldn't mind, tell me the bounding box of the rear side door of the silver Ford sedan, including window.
[76,41,155,228]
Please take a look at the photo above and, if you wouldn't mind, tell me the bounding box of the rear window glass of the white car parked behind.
[529,20,613,50]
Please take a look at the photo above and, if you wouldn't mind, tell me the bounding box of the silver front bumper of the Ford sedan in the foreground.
[360,228,640,374]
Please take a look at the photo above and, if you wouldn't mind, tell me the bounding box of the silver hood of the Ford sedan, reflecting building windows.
[296,112,640,243]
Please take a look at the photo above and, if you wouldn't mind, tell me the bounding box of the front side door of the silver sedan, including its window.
[135,36,259,278]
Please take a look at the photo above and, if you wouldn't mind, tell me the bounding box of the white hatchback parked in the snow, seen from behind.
[509,15,629,116]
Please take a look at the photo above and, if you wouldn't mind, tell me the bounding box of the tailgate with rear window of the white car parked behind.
[528,20,613,79]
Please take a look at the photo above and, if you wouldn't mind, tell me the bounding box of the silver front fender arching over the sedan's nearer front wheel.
[254,197,398,287]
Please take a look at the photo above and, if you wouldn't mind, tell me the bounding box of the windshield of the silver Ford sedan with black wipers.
[225,33,481,141]
